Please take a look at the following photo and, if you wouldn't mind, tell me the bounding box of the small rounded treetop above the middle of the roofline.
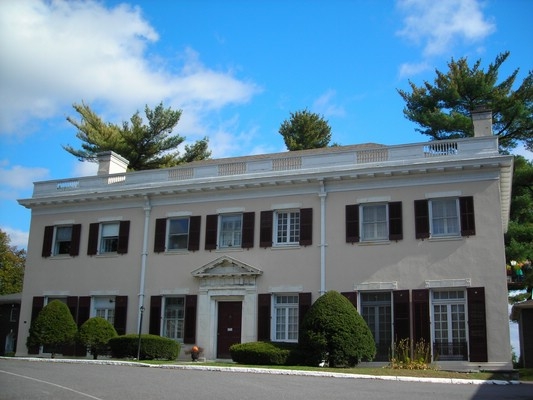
[279,110,331,151]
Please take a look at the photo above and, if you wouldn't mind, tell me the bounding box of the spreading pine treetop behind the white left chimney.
[63,103,211,171]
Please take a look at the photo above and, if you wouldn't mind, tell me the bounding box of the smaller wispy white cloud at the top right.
[398,0,495,57]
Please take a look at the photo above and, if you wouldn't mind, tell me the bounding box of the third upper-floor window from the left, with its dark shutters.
[154,216,200,253]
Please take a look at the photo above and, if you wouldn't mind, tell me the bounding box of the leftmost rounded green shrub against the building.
[26,300,78,358]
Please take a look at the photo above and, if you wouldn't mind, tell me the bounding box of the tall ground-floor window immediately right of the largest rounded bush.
[361,292,392,361]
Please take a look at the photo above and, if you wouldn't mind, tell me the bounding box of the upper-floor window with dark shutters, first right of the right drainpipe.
[346,201,403,243]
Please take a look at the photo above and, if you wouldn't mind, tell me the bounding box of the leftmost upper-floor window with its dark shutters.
[42,224,81,257]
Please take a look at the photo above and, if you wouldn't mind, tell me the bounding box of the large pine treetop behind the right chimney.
[398,52,533,151]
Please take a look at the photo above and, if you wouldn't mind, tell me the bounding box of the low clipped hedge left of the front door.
[109,333,180,360]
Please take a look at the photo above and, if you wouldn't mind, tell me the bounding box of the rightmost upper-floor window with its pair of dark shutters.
[415,196,476,239]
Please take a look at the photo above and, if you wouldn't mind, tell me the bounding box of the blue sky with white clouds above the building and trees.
[0,0,533,247]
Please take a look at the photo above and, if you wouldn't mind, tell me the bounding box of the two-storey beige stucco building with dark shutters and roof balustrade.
[17,110,512,368]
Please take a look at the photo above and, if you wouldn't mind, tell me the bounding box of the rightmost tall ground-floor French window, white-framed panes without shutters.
[432,290,467,361]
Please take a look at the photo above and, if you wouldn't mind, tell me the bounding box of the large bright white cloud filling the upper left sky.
[0,0,260,134]
